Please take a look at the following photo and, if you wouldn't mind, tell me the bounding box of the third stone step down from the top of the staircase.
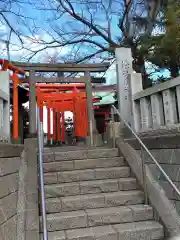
[44,166,130,184]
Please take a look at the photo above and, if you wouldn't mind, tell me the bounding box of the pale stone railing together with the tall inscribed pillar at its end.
[115,48,180,133]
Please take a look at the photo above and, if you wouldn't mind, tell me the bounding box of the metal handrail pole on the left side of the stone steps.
[37,108,48,240]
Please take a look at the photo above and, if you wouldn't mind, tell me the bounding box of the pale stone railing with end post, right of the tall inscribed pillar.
[130,73,180,132]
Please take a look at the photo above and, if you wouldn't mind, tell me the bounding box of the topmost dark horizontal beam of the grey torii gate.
[12,62,109,72]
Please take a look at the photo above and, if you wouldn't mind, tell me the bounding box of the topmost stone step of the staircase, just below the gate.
[44,148,119,162]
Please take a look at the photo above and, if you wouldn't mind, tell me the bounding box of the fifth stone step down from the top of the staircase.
[46,190,144,213]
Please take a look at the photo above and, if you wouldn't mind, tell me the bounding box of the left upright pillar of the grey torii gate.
[29,70,36,137]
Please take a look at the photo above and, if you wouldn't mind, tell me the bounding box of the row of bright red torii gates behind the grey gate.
[36,84,99,142]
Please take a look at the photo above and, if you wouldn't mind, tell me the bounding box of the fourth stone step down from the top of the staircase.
[45,178,137,198]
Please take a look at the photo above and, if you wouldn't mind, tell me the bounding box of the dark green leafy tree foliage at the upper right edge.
[138,2,180,78]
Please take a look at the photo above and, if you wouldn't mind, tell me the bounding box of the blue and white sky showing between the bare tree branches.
[0,0,172,105]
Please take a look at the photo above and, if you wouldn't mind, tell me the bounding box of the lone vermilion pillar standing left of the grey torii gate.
[12,73,19,143]
